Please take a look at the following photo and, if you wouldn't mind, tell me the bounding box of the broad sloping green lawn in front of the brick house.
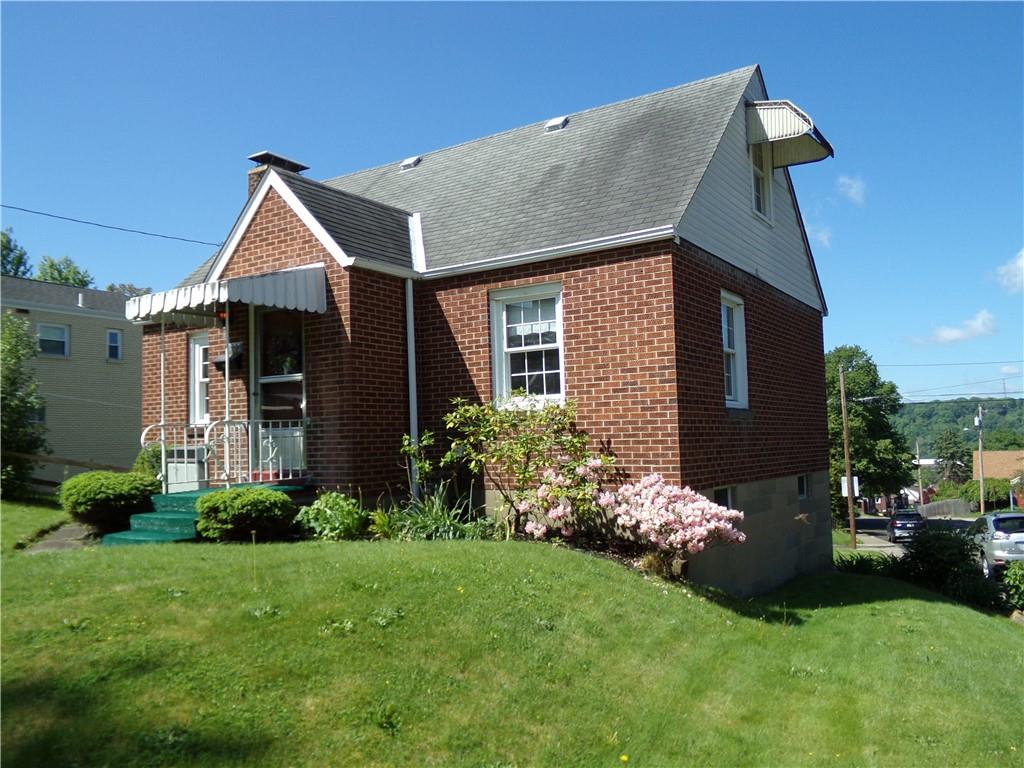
[2,542,1024,766]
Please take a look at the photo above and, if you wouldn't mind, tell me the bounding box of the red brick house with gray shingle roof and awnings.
[127,67,831,593]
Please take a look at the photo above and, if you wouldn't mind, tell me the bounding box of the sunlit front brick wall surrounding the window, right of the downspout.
[416,243,679,480]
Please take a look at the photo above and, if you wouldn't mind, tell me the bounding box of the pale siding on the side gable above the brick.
[678,77,822,310]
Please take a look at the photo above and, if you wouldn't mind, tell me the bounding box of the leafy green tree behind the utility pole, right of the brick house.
[825,346,912,517]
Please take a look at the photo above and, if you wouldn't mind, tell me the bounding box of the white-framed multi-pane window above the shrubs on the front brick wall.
[490,284,565,401]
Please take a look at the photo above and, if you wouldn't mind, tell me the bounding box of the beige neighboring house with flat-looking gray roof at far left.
[0,276,142,485]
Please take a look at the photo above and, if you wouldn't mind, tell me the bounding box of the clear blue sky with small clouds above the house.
[0,2,1024,399]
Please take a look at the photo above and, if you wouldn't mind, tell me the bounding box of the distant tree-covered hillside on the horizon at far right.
[892,397,1024,458]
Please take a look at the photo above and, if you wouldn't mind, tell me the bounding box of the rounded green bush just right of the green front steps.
[196,487,295,542]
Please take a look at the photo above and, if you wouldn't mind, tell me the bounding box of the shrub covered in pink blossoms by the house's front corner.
[598,474,746,553]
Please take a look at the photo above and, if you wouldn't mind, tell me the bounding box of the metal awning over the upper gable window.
[746,99,836,168]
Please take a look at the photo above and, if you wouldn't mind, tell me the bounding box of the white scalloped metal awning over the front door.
[125,264,327,322]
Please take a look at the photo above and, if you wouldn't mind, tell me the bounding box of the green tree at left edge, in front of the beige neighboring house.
[0,312,47,498]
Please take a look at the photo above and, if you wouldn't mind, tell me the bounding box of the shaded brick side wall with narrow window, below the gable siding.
[673,242,828,487]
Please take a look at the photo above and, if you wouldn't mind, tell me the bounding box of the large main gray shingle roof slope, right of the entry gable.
[324,67,755,268]
